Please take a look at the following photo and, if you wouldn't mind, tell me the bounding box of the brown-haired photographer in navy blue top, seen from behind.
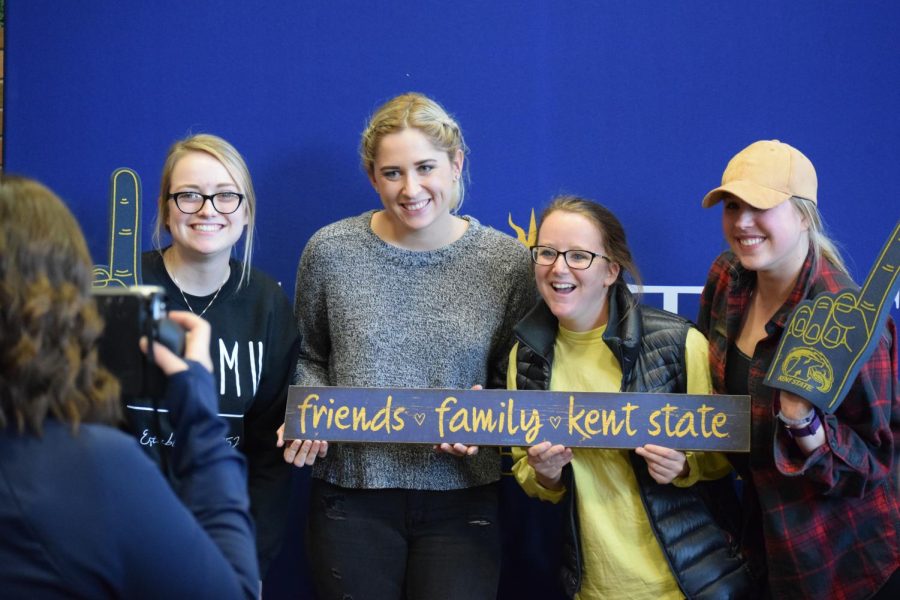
[0,176,258,598]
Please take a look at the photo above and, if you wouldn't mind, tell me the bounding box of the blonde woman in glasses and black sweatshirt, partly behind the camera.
[137,134,299,576]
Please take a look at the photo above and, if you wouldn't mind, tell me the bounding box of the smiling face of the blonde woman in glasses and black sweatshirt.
[166,152,247,258]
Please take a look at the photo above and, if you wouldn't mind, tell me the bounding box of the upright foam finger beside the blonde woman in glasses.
[93,168,141,288]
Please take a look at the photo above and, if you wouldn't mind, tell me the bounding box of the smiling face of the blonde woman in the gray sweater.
[369,128,463,238]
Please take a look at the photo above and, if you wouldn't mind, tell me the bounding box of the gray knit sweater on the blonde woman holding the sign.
[294,211,536,490]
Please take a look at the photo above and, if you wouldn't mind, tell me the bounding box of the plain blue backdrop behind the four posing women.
[4,0,900,597]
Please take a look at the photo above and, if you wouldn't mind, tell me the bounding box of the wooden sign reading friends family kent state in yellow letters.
[284,386,750,452]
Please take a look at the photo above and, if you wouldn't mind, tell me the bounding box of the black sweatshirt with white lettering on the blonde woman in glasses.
[134,250,299,575]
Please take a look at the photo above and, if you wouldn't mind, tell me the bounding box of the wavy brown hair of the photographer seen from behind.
[0,175,121,435]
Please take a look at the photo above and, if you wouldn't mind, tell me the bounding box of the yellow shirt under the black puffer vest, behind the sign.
[507,326,731,600]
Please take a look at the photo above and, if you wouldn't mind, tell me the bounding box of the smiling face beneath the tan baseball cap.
[722,195,809,279]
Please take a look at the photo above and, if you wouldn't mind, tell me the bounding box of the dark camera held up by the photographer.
[91,285,184,398]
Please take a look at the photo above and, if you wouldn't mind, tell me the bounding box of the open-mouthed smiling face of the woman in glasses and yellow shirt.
[534,210,620,331]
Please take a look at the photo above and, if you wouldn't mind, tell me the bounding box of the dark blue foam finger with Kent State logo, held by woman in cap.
[765,222,900,413]
